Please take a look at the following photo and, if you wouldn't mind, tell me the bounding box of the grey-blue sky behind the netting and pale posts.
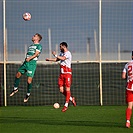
[0,0,133,52]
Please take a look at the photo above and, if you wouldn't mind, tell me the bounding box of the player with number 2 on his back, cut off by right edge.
[122,51,133,128]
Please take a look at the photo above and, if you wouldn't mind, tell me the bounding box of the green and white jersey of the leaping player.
[26,44,42,61]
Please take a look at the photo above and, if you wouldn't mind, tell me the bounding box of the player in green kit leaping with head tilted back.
[10,33,42,102]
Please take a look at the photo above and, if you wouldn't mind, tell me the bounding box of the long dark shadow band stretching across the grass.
[0,117,125,128]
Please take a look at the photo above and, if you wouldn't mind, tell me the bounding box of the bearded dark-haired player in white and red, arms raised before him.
[46,42,76,112]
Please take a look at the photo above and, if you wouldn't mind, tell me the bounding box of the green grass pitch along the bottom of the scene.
[0,106,133,133]
